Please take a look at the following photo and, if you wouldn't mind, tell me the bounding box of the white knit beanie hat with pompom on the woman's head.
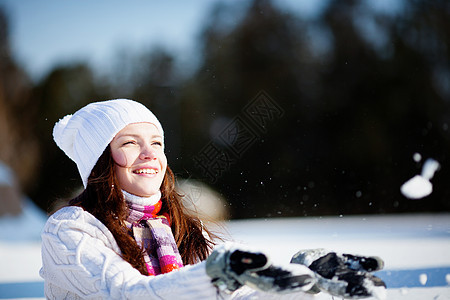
[53,99,164,187]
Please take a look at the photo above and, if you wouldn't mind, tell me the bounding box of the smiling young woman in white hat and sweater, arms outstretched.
[41,99,381,299]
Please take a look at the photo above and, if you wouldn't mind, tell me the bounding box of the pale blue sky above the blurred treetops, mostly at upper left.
[0,0,395,79]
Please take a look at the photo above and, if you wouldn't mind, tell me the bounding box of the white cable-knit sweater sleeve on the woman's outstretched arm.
[41,207,223,299]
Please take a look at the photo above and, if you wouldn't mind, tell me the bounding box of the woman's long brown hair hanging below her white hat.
[69,146,216,275]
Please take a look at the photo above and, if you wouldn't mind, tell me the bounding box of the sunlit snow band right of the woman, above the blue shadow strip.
[226,214,450,269]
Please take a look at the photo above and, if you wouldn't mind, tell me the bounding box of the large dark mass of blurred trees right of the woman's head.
[178,0,450,218]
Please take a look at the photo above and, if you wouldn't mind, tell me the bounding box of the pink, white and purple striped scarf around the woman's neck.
[123,191,183,276]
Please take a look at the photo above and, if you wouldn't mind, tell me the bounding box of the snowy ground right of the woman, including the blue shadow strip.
[227,214,450,300]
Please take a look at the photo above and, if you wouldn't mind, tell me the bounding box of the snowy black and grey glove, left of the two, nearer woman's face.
[206,244,316,293]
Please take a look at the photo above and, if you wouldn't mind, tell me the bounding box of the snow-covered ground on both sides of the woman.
[0,202,450,300]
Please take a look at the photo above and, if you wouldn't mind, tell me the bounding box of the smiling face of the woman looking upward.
[110,123,167,197]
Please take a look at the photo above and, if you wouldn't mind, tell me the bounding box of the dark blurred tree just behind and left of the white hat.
[30,63,109,211]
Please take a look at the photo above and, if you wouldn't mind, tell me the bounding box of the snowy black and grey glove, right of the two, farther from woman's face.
[291,249,386,299]
